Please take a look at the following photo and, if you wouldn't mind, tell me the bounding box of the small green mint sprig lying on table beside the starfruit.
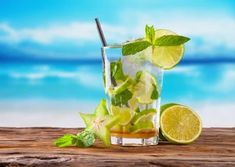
[54,130,95,147]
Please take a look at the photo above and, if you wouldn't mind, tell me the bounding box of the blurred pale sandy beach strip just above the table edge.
[0,100,235,127]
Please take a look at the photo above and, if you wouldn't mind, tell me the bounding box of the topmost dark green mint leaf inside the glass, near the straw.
[110,60,126,81]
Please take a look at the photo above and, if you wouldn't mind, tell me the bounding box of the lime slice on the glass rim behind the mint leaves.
[151,29,184,69]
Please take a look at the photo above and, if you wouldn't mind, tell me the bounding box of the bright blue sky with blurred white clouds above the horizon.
[0,0,235,58]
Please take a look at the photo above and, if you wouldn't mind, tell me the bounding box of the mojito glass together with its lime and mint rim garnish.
[102,26,188,145]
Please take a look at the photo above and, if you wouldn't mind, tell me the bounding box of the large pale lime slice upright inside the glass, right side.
[133,71,159,104]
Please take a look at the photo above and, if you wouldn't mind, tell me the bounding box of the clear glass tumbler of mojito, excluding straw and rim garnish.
[102,45,163,146]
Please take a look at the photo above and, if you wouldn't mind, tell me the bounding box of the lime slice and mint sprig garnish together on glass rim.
[122,25,190,69]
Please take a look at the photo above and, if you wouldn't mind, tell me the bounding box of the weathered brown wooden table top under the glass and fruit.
[0,128,235,167]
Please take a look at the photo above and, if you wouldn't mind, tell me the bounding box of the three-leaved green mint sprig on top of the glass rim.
[122,25,190,56]
